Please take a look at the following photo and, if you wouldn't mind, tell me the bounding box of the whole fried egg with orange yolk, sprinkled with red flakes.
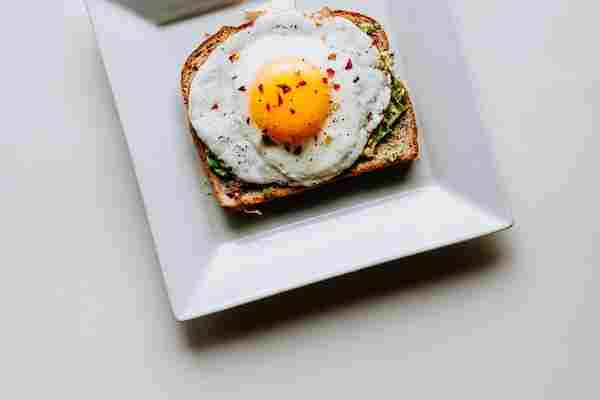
[188,11,391,186]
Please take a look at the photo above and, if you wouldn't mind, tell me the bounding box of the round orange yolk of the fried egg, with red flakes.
[248,58,330,143]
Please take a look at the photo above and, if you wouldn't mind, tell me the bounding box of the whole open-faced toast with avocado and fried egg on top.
[181,8,419,209]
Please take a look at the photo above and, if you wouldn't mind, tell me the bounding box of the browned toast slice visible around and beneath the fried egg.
[181,10,419,210]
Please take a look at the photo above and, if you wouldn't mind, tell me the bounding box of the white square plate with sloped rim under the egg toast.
[87,0,512,320]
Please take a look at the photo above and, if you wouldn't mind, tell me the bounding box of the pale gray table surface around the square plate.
[0,0,600,400]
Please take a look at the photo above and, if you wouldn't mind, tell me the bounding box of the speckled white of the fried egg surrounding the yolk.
[189,11,391,186]
